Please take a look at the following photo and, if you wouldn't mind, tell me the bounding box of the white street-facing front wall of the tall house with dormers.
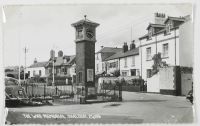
[140,29,179,80]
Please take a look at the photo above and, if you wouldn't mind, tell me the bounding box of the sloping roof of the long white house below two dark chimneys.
[105,48,139,61]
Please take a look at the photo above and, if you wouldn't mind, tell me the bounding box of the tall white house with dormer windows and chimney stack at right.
[139,13,193,80]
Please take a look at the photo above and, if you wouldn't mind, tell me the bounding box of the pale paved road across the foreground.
[7,92,193,123]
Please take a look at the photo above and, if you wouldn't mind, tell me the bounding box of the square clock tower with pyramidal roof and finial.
[72,15,99,100]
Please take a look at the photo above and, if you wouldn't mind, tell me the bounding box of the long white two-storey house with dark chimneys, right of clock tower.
[106,42,140,76]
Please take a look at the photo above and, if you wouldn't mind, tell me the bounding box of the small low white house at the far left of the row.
[26,59,48,78]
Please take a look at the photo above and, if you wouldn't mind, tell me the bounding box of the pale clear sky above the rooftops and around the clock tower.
[3,4,192,66]
